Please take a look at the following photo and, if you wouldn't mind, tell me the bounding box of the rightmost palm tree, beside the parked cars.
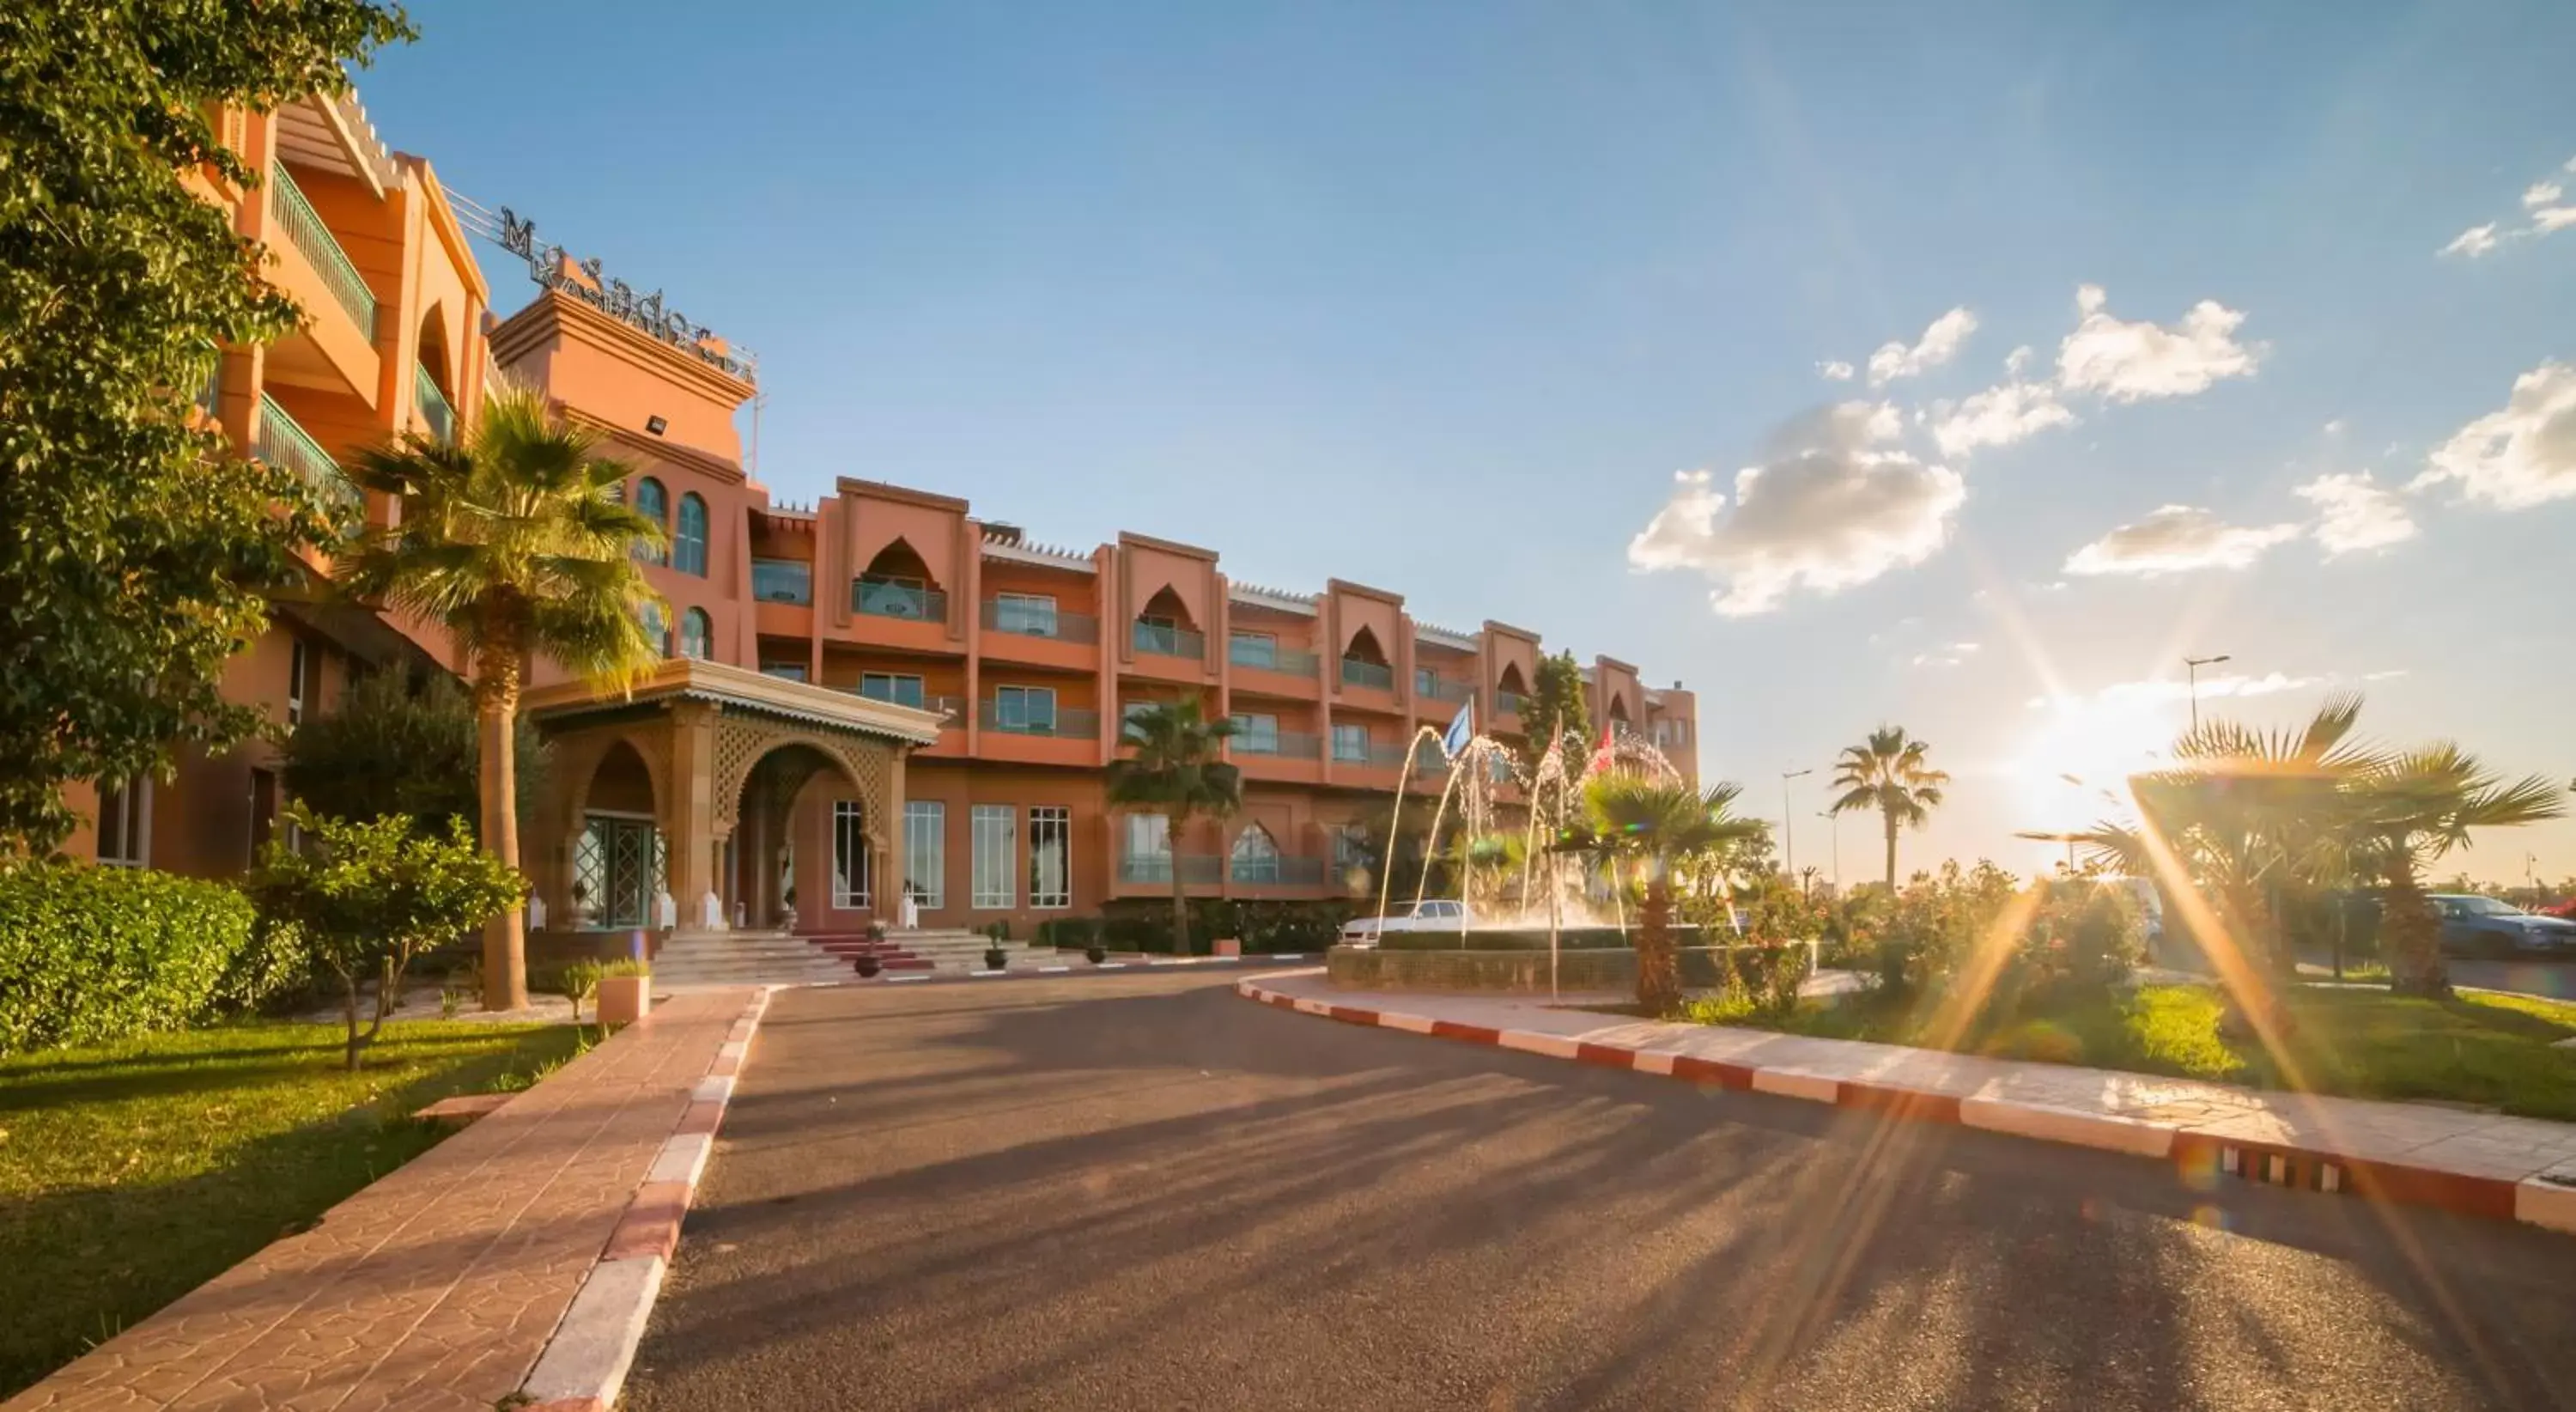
[2344,742,2563,997]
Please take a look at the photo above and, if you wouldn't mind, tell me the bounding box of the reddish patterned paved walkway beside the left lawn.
[0,989,755,1412]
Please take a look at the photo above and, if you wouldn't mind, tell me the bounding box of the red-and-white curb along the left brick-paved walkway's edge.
[518,987,778,1412]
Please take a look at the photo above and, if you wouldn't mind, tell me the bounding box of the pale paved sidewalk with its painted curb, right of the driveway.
[1236,971,2576,1232]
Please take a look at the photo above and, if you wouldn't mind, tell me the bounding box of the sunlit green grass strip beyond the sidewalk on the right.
[1700,984,2576,1121]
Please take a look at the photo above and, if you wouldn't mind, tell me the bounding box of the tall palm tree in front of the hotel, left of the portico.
[337,386,665,1010]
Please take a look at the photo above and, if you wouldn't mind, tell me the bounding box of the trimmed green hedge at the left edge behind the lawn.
[0,863,274,1054]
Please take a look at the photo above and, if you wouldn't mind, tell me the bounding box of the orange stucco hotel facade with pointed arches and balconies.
[60,74,1698,935]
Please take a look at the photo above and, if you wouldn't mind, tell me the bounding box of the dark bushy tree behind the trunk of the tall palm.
[281,673,546,830]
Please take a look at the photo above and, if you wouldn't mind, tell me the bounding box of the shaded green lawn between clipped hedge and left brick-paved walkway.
[0,1020,582,1397]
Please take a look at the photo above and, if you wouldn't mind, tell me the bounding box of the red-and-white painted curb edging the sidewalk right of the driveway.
[1234,979,2576,1232]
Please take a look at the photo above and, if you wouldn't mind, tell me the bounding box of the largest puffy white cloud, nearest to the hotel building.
[1628,402,1968,618]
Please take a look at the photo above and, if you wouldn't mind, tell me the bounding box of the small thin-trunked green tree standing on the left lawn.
[250,806,528,1069]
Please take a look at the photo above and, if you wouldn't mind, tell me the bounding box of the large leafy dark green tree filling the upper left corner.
[0,0,410,855]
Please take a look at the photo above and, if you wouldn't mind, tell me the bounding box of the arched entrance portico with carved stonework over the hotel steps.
[520,660,940,930]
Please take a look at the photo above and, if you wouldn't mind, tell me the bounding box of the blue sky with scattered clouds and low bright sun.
[361,3,2576,879]
